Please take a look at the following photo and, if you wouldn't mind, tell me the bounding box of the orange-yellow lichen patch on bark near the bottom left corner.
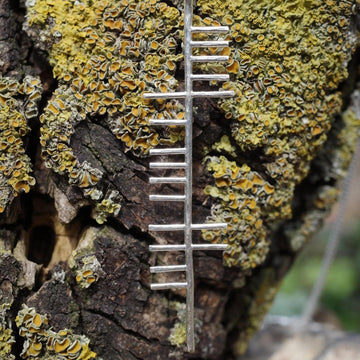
[15,305,96,360]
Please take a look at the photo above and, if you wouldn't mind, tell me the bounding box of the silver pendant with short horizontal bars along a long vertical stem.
[143,0,234,352]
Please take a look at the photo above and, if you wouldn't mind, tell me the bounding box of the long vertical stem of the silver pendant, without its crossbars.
[184,0,195,352]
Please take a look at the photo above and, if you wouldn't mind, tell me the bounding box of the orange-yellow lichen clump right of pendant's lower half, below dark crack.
[203,156,276,269]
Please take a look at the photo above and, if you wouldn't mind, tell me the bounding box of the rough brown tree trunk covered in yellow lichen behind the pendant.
[0,0,360,360]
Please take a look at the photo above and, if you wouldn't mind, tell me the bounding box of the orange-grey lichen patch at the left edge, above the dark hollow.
[0,76,42,213]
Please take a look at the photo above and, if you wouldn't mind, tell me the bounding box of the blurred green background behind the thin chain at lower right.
[270,155,360,332]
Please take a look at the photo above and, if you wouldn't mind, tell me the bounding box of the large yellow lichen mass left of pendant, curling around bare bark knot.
[26,0,183,223]
